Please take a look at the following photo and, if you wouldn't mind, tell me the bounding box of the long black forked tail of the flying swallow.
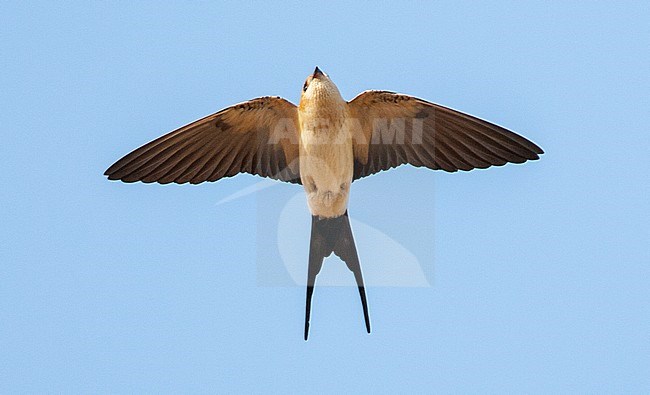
[305,211,370,340]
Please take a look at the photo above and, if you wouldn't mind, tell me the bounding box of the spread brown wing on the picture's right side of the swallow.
[348,91,544,180]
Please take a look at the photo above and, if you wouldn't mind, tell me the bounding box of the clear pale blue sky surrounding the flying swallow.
[0,1,650,393]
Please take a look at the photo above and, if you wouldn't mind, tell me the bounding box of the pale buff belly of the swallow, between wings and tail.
[300,131,354,218]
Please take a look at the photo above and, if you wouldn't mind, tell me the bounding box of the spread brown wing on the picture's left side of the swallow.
[104,97,300,184]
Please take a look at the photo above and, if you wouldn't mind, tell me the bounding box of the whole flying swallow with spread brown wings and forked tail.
[104,67,544,340]
